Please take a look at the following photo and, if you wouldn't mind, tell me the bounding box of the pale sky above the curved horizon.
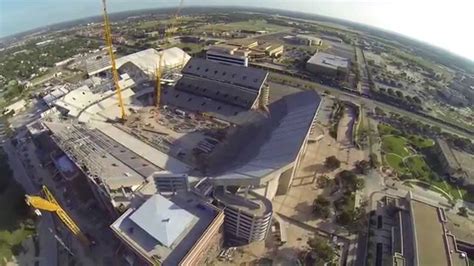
[0,0,474,60]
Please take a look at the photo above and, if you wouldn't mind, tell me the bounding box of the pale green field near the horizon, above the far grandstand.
[201,19,290,32]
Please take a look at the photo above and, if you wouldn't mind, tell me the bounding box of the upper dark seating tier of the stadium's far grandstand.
[182,58,268,91]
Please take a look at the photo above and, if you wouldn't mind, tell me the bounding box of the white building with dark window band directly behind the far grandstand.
[206,45,249,67]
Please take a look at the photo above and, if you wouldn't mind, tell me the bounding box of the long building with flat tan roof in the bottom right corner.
[367,194,468,266]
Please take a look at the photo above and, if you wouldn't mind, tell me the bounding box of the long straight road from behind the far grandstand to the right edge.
[268,72,474,139]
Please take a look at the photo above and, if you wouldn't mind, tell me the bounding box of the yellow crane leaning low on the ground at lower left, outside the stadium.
[25,186,91,246]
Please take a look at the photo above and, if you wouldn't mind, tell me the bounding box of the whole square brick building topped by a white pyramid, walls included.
[110,192,224,266]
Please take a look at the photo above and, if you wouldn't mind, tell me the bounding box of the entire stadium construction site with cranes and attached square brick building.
[17,1,321,265]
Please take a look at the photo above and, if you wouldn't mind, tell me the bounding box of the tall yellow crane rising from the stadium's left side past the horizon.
[102,0,126,120]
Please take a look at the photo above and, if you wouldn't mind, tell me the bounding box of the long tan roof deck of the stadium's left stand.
[44,122,157,190]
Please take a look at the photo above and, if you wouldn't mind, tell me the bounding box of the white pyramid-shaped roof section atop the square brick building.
[130,194,198,247]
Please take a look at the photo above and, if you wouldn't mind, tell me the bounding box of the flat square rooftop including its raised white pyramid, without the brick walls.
[111,192,221,265]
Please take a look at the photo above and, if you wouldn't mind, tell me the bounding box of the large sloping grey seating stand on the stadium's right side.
[211,91,321,184]
